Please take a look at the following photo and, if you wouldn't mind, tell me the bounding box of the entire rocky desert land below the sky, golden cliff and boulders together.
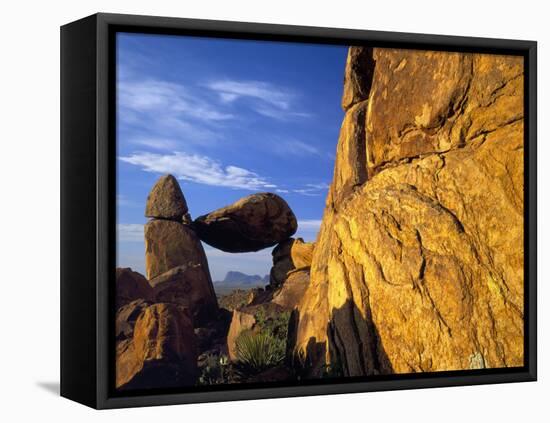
[114,47,524,390]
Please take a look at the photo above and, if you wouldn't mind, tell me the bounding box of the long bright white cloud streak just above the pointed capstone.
[119,152,277,191]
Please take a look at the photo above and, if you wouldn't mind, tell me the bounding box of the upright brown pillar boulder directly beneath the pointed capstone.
[145,220,212,284]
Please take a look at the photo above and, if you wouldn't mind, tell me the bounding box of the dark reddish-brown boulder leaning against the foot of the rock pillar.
[149,263,218,323]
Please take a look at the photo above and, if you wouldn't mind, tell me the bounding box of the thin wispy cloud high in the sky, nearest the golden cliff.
[205,79,311,120]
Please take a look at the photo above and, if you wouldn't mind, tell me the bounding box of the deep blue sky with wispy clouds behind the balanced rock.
[117,34,347,280]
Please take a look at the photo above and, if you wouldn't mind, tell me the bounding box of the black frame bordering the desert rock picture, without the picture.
[61,13,537,409]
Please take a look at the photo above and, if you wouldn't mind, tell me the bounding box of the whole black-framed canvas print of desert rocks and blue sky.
[61,14,536,408]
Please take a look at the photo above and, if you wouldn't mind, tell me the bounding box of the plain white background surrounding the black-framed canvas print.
[0,0,550,423]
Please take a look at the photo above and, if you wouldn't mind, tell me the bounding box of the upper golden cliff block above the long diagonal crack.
[366,49,523,175]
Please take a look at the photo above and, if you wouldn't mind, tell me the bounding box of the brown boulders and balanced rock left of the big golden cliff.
[115,175,312,390]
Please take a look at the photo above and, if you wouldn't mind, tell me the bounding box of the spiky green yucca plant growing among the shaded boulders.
[235,330,285,374]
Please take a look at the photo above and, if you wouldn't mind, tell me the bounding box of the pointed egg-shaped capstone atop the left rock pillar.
[145,175,187,220]
